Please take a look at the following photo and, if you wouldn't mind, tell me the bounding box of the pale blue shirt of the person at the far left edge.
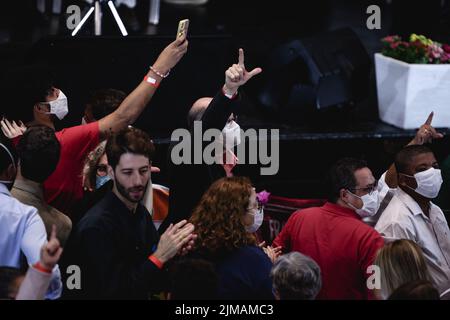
[0,183,62,299]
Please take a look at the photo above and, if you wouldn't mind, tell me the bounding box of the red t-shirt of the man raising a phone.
[44,122,100,216]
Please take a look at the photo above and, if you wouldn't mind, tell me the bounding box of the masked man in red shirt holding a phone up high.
[0,37,188,216]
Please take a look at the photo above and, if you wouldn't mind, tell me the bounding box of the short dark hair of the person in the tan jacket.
[17,126,61,183]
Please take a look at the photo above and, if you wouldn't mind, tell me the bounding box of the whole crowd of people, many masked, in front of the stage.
[0,33,450,300]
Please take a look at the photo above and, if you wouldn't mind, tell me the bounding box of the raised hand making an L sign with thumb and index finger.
[223,48,262,95]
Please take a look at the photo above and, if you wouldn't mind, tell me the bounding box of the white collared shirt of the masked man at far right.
[375,188,450,293]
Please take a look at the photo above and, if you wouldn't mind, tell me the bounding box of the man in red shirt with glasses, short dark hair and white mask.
[273,158,384,299]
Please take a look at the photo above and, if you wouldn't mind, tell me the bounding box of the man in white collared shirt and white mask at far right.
[375,145,450,293]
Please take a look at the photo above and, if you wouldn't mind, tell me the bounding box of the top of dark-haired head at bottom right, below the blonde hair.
[388,280,440,300]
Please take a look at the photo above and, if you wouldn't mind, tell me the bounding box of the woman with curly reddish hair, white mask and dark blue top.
[190,177,273,299]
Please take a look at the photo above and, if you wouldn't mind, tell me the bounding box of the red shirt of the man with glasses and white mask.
[273,202,384,299]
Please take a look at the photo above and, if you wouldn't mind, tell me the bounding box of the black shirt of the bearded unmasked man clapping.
[63,192,165,299]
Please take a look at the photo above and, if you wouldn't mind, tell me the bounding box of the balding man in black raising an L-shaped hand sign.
[158,49,262,234]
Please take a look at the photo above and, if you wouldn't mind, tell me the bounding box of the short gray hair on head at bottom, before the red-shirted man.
[270,252,322,300]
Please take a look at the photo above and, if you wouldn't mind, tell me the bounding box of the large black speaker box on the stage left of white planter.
[258,28,371,121]
